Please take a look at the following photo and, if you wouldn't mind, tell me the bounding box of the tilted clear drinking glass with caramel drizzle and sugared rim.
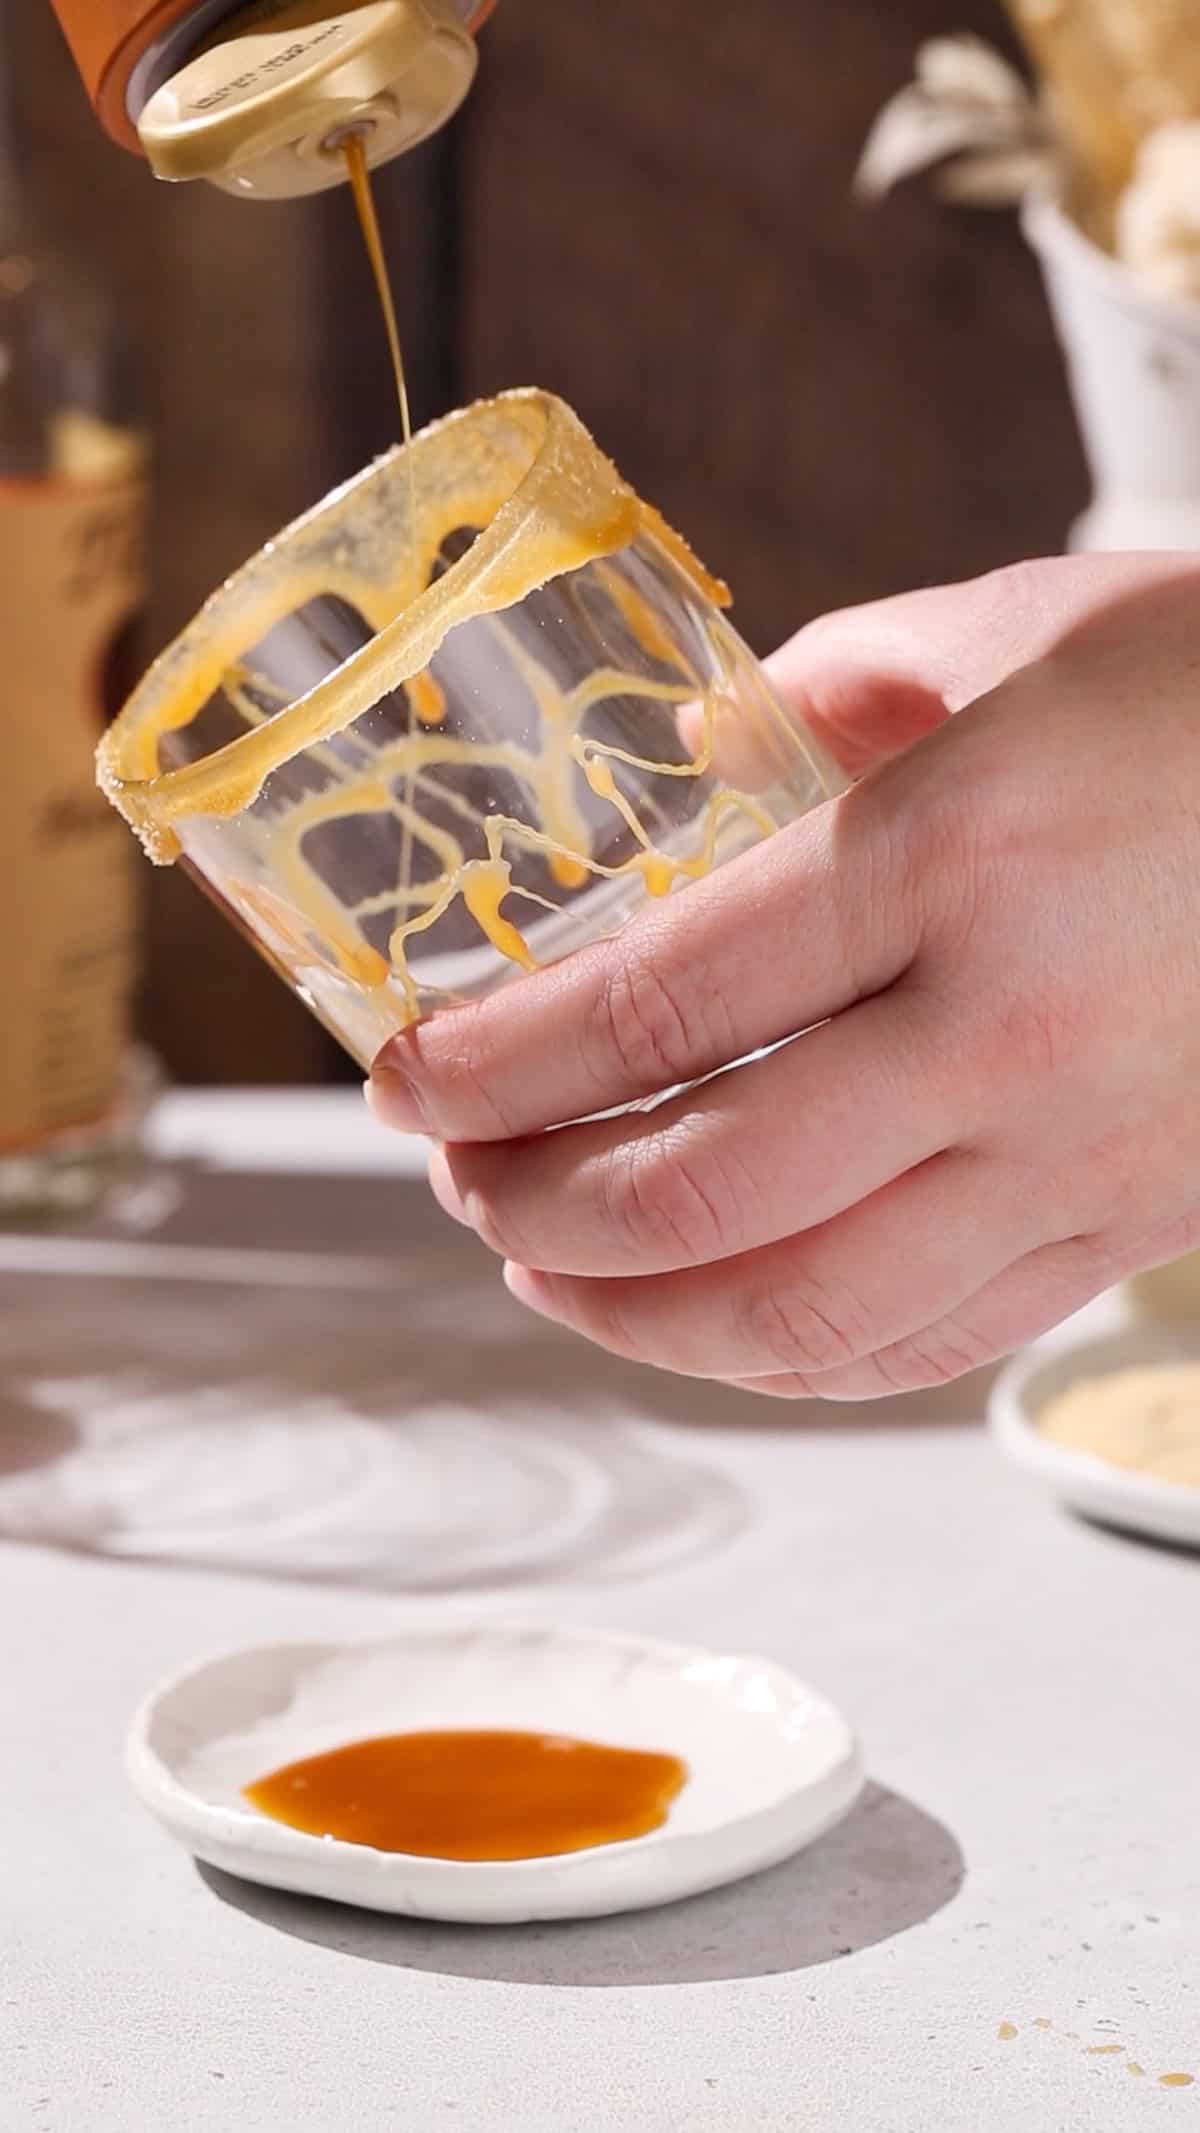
[100,392,836,1067]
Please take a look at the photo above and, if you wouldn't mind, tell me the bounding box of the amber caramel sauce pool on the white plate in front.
[243,1730,688,1860]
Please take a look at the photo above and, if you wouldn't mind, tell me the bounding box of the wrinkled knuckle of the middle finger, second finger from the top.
[603,1128,744,1265]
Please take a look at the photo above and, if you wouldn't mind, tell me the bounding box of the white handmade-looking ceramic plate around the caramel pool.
[126,1623,863,1924]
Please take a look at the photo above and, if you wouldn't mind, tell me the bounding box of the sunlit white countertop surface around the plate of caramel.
[0,1092,1200,2133]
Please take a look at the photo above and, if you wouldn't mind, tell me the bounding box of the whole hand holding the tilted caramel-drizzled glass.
[373,557,1200,1399]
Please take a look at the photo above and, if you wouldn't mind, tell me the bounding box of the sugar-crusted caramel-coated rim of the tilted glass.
[96,386,731,864]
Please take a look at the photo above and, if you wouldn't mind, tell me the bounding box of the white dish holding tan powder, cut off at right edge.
[987,1325,1200,1549]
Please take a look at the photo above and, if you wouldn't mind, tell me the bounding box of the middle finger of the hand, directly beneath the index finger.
[431,988,970,1278]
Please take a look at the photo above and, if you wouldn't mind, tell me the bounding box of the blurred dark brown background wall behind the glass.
[11,0,1083,1081]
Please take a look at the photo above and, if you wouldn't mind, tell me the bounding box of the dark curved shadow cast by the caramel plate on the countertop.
[196,1785,966,1988]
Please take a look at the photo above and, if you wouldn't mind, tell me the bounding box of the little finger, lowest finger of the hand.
[720,1237,1123,1401]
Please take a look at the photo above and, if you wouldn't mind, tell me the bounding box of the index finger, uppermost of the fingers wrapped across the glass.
[371,793,921,1141]
